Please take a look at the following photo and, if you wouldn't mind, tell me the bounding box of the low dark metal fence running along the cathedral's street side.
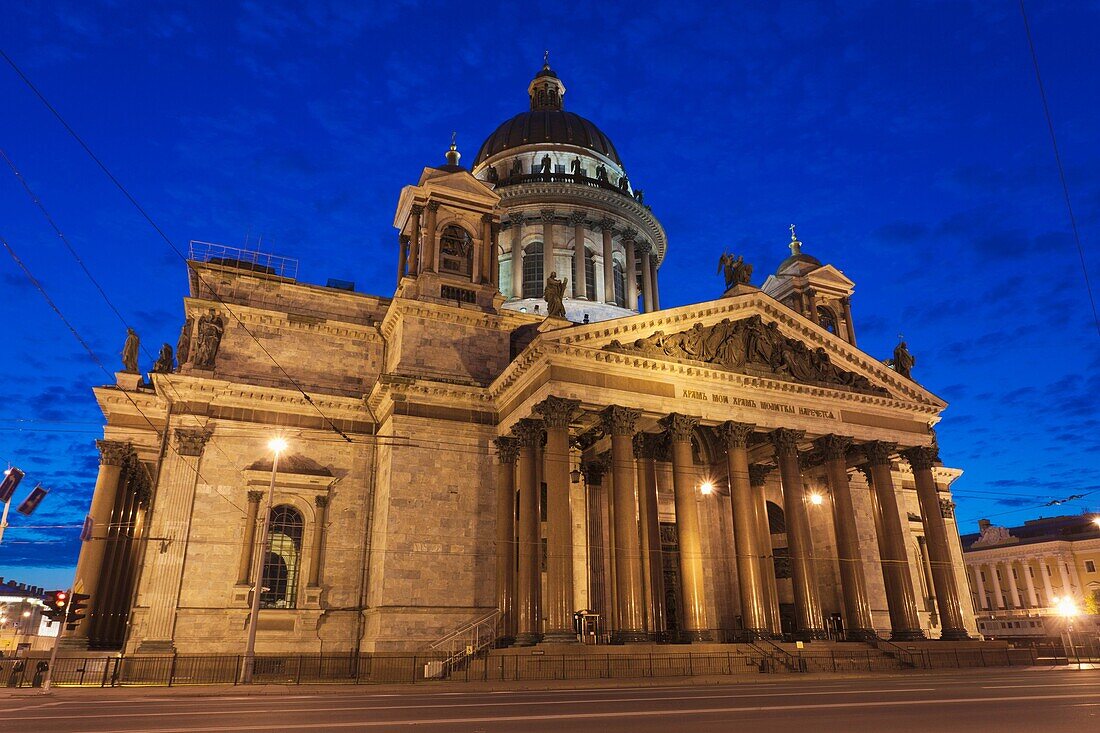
[0,645,1073,687]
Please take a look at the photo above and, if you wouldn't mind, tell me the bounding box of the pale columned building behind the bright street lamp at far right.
[961,514,1100,638]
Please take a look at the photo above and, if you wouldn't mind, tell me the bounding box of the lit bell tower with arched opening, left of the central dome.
[394,135,504,309]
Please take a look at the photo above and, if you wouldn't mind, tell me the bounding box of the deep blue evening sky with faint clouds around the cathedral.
[0,0,1100,587]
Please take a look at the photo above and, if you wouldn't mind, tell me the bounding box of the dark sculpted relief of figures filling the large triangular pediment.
[604,315,890,396]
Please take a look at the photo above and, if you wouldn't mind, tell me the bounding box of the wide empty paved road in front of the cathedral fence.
[0,669,1100,733]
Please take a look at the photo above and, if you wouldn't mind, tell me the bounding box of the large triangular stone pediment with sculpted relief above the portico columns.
[537,291,946,408]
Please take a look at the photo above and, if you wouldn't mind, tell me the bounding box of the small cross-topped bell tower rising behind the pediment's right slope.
[760,225,856,346]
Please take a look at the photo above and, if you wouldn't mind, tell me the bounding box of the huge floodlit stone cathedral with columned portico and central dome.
[65,64,977,655]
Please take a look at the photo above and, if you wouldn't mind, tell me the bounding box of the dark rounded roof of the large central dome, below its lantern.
[474,109,623,167]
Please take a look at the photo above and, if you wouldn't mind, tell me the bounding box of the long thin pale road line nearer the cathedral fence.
[4,687,941,721]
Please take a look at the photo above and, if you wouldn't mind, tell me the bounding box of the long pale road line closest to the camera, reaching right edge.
[68,692,1100,733]
